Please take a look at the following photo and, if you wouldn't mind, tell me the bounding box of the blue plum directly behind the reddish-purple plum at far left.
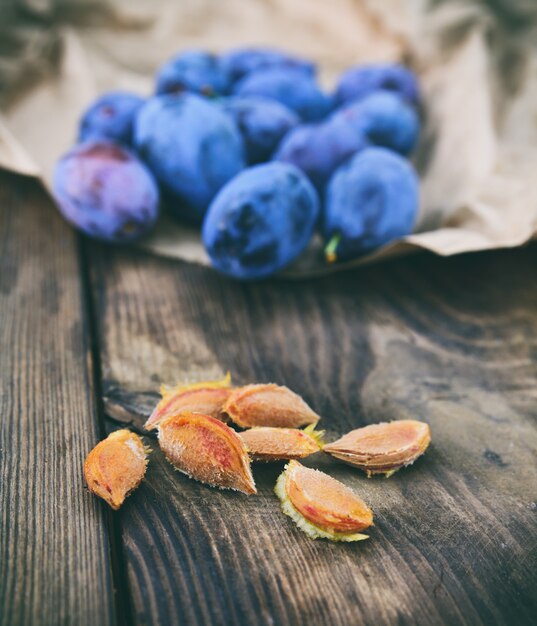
[78,91,145,145]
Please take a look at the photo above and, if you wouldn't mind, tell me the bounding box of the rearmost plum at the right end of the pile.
[335,63,420,106]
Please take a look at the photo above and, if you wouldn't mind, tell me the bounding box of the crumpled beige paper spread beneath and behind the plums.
[0,0,537,276]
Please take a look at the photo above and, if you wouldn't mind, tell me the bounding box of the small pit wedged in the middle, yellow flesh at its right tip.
[239,426,323,461]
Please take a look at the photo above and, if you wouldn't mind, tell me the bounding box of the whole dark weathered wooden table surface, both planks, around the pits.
[0,174,537,626]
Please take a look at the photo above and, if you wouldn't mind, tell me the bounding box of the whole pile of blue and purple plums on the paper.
[53,48,420,279]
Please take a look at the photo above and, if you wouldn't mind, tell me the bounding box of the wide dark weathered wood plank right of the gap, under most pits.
[92,240,537,626]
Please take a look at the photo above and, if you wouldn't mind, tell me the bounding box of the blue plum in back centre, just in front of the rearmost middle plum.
[233,67,332,122]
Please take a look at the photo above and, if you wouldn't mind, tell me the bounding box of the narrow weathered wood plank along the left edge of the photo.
[0,173,115,626]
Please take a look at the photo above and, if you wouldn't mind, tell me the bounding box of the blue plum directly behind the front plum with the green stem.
[333,91,420,155]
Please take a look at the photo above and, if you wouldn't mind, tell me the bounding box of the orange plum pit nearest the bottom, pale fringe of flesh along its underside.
[274,461,373,541]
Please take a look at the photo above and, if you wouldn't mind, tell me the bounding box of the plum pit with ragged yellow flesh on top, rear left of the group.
[144,374,231,430]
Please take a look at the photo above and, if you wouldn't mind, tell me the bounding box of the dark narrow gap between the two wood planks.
[77,234,133,626]
